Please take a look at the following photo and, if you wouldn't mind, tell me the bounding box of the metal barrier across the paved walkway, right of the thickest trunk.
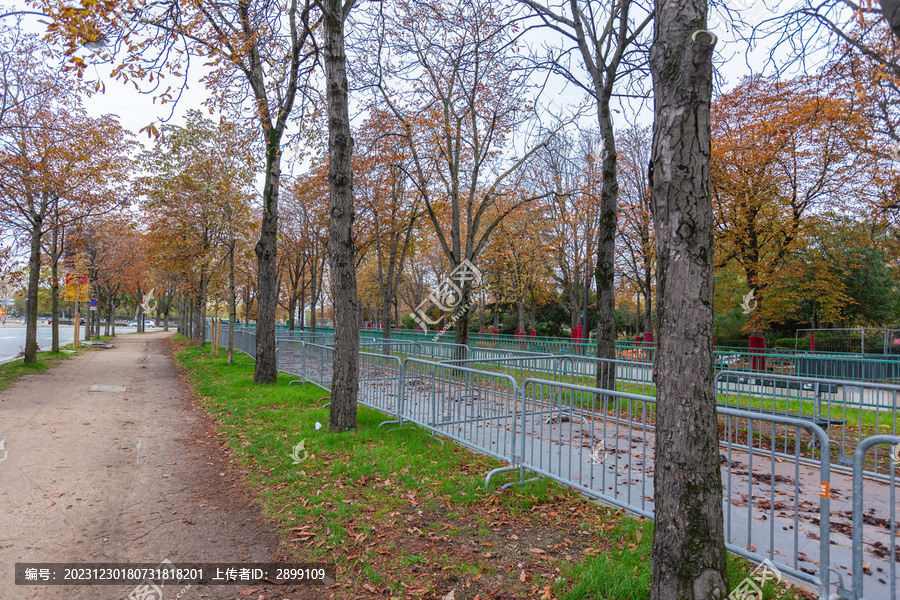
[715,371,900,479]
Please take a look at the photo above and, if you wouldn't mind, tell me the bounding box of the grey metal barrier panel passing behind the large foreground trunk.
[515,379,831,598]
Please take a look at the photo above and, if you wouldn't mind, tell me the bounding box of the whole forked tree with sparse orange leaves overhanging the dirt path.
[36,0,326,383]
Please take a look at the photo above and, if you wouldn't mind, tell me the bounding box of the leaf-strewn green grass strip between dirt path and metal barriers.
[177,338,816,600]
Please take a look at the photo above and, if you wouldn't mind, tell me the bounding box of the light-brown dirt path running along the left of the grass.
[0,333,306,600]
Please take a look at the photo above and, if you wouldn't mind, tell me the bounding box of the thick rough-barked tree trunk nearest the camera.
[650,10,728,600]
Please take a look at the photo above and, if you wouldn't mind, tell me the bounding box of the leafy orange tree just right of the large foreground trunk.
[712,76,870,333]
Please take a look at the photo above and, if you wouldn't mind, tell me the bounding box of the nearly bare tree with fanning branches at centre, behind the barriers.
[373,0,552,344]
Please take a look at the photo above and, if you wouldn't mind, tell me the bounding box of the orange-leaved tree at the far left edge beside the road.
[0,37,133,362]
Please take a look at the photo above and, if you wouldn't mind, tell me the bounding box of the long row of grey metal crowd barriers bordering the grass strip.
[200,332,900,600]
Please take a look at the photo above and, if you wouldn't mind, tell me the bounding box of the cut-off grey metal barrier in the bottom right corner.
[833,435,900,600]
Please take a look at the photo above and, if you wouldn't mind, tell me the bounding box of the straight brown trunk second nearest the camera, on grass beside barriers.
[322,0,359,431]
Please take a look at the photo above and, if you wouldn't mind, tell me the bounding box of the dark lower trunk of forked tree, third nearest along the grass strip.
[248,129,281,383]
